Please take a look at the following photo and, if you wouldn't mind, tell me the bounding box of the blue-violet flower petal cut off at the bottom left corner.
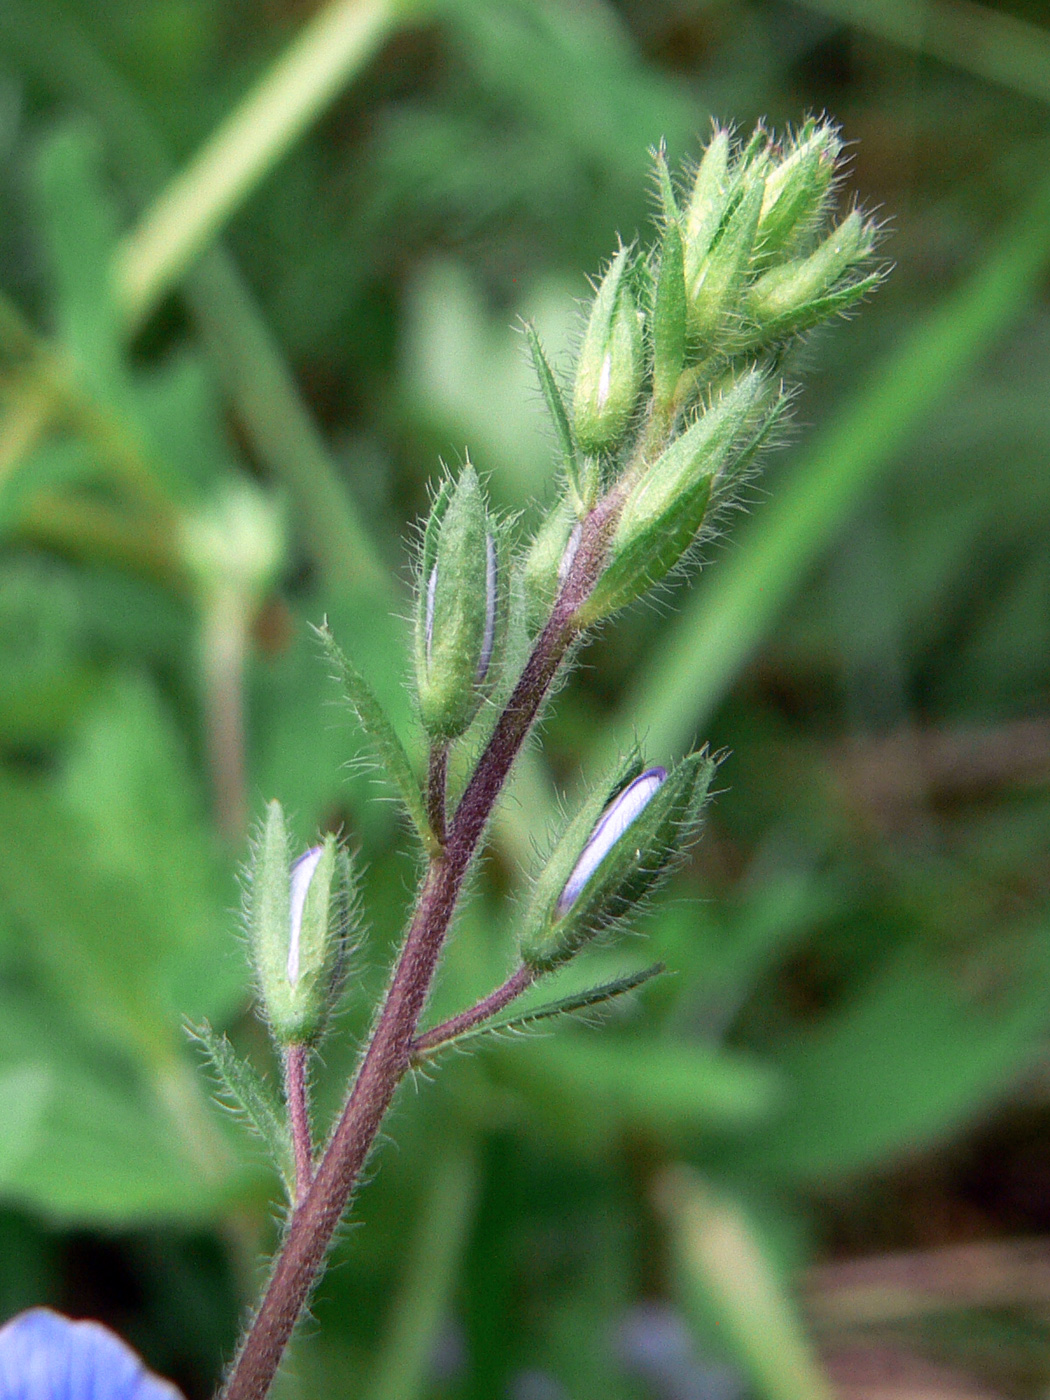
[0,1308,182,1400]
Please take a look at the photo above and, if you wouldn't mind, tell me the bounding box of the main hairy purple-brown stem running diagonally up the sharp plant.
[224,503,613,1400]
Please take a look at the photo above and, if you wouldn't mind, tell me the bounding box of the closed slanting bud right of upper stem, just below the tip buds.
[580,370,776,624]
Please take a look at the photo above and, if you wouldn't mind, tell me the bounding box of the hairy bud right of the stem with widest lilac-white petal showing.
[521,753,715,973]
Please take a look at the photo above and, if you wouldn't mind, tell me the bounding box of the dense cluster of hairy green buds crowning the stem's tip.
[525,120,881,623]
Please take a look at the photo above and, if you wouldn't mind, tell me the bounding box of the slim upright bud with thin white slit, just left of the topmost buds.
[573,248,644,452]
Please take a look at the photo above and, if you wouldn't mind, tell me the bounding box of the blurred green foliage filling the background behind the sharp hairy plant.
[0,0,1050,1400]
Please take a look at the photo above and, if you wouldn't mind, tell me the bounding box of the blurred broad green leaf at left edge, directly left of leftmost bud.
[0,676,245,1057]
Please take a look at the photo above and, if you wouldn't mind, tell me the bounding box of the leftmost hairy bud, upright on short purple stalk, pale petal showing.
[248,802,354,1046]
